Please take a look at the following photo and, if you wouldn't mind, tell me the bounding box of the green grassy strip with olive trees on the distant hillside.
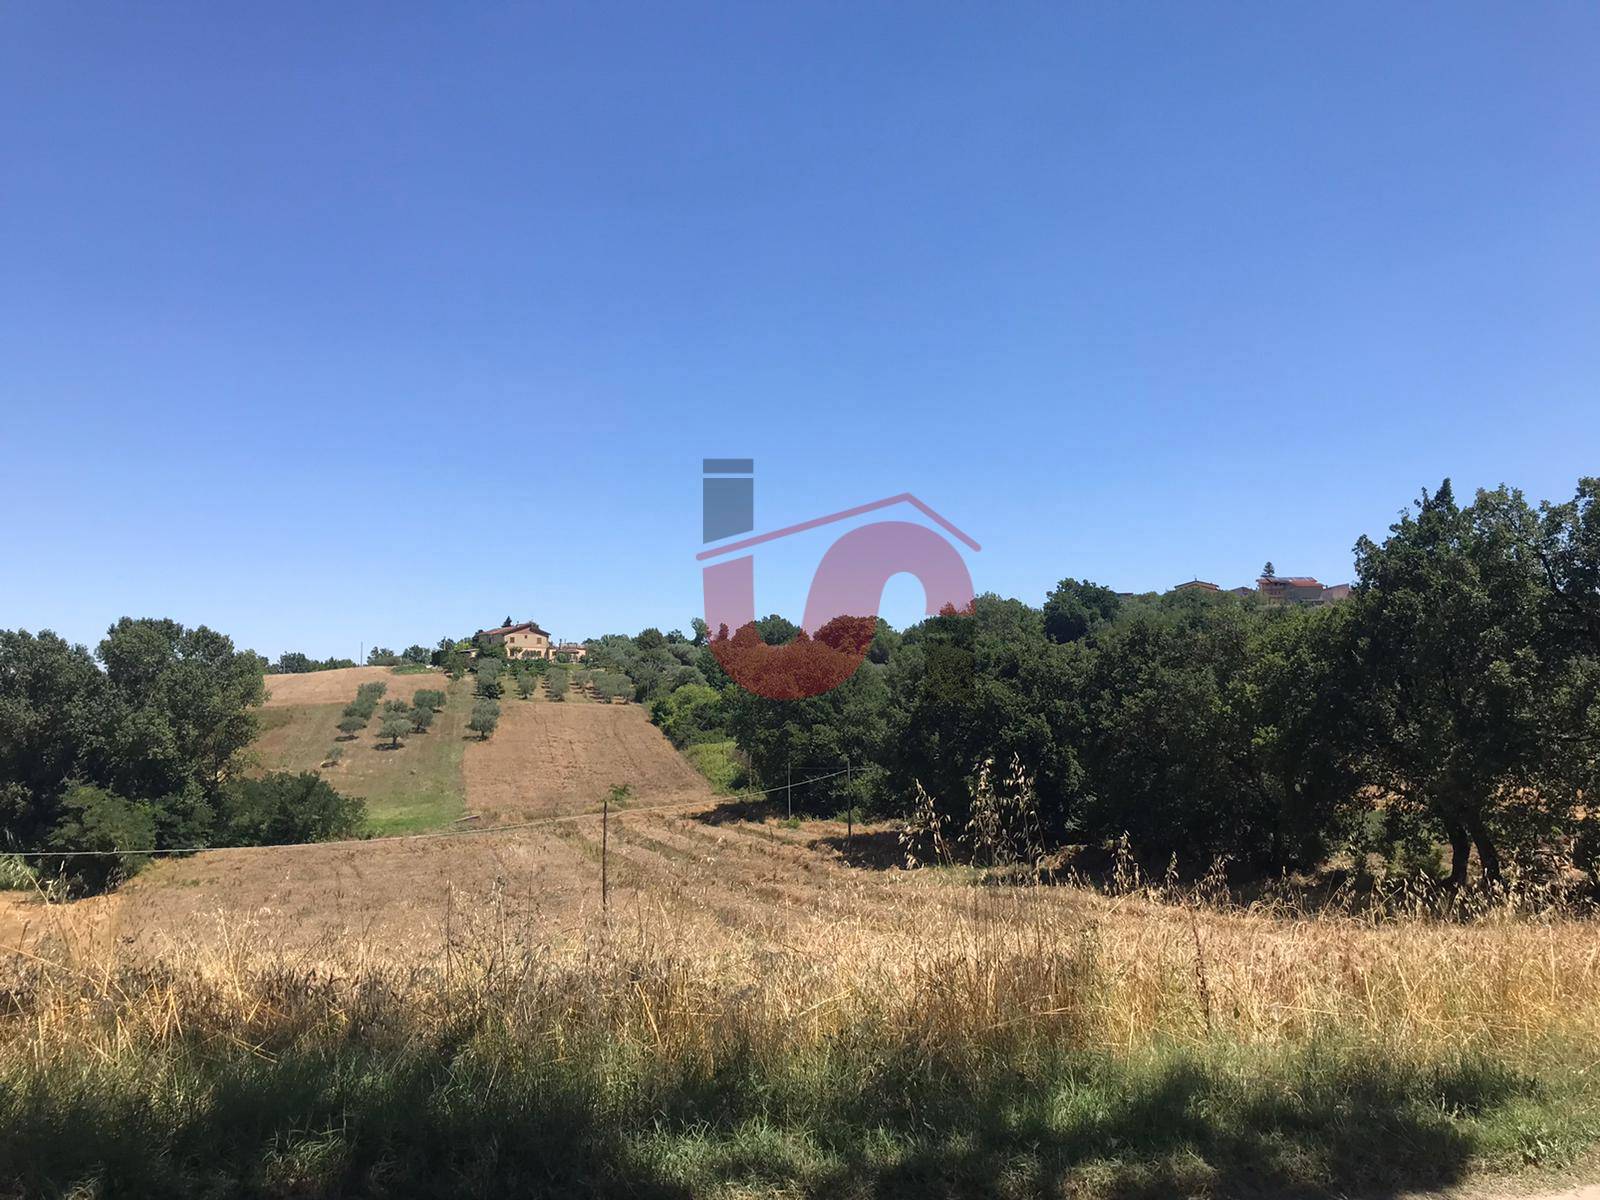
[253,672,474,835]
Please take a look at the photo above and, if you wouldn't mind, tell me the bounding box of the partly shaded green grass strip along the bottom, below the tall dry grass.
[0,1018,1600,1200]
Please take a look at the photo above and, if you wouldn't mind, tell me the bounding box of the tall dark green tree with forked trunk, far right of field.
[1354,480,1570,885]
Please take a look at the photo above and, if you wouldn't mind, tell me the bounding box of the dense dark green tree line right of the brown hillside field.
[590,478,1600,885]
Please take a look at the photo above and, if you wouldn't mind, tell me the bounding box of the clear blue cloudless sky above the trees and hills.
[0,0,1600,656]
